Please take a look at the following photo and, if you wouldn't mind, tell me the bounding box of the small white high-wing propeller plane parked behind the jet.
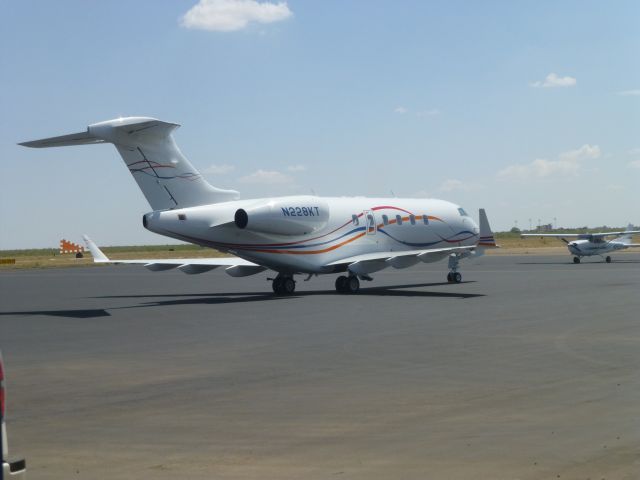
[522,224,640,263]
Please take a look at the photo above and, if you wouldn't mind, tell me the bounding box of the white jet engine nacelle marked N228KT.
[234,197,329,235]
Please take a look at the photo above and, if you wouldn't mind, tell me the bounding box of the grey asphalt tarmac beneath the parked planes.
[0,254,640,480]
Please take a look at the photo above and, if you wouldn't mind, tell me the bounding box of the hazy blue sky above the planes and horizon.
[0,0,640,248]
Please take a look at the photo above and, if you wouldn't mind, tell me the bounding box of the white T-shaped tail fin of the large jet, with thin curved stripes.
[20,117,239,210]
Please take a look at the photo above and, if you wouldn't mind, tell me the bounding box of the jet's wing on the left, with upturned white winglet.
[83,235,267,277]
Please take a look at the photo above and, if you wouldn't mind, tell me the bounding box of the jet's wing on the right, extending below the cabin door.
[326,245,480,275]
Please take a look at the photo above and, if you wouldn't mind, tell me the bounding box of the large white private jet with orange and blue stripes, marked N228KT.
[20,117,496,294]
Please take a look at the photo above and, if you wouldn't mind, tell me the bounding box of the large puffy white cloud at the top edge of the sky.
[180,0,293,32]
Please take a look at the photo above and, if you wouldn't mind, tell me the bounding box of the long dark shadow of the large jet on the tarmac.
[0,282,485,319]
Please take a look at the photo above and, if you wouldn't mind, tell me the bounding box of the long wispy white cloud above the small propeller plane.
[498,144,602,179]
